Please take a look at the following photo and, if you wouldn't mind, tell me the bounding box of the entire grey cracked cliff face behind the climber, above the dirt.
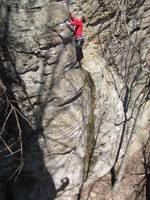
[0,0,150,200]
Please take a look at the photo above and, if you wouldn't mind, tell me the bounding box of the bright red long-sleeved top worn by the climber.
[70,17,83,38]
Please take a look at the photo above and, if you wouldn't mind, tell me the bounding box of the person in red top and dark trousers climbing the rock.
[67,14,84,65]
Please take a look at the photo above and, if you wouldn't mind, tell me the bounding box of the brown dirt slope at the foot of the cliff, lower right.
[78,138,150,200]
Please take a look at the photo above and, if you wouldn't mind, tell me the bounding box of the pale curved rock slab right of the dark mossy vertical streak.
[83,44,124,180]
